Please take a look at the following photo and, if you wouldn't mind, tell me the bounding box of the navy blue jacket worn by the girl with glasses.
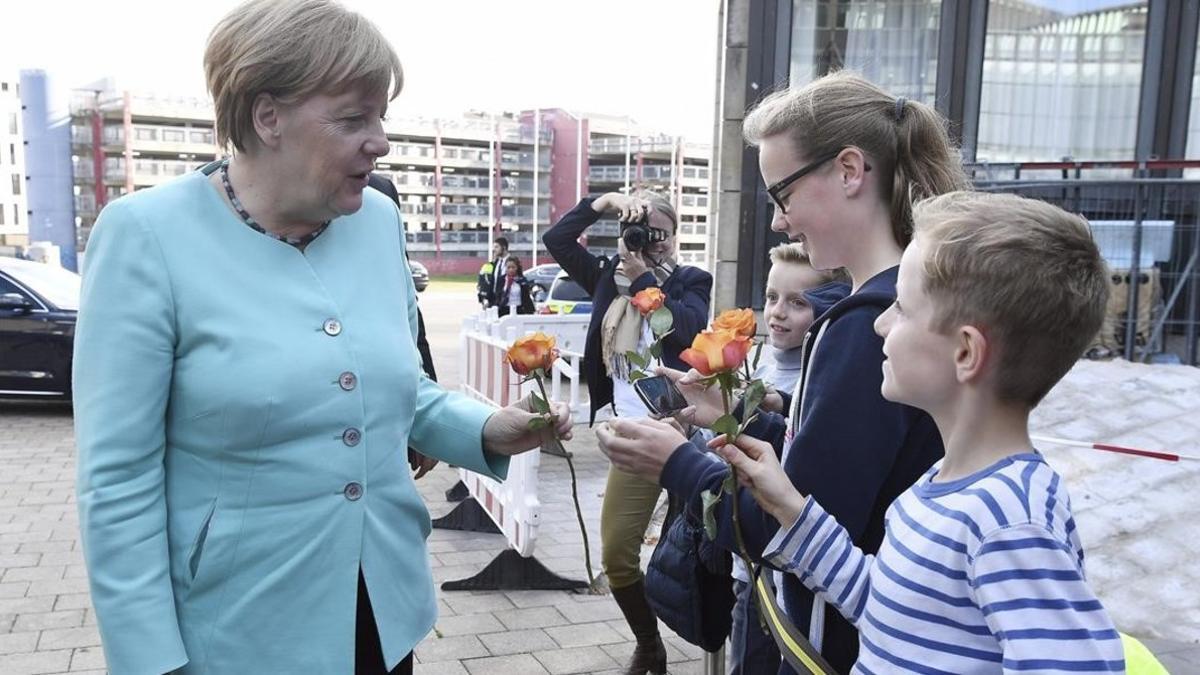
[660,268,943,673]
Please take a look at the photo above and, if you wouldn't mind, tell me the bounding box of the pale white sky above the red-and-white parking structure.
[0,0,718,142]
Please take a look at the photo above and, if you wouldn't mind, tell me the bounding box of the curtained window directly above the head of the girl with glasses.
[790,0,942,103]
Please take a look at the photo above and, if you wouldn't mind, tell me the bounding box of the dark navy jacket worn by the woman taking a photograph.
[541,197,713,422]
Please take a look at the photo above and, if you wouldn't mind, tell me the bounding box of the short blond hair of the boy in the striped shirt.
[913,192,1109,407]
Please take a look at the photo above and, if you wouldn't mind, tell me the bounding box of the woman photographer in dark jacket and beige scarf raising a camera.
[542,192,713,675]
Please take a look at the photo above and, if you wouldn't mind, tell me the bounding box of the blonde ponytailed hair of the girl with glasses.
[743,71,968,246]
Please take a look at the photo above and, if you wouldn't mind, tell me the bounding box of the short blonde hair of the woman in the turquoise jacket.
[204,0,404,153]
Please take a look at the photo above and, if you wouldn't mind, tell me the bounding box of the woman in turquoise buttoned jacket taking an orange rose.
[73,0,569,675]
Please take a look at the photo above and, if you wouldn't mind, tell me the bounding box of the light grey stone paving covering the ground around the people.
[0,362,1200,675]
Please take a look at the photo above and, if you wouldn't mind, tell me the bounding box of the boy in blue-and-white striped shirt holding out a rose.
[714,192,1124,675]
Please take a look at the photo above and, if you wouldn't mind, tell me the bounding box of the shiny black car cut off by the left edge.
[0,257,79,399]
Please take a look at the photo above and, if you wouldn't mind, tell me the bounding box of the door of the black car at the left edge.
[0,273,66,395]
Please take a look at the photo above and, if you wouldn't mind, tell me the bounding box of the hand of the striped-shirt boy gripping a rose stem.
[708,434,808,527]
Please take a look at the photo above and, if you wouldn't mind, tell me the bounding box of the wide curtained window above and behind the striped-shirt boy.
[976,0,1147,162]
